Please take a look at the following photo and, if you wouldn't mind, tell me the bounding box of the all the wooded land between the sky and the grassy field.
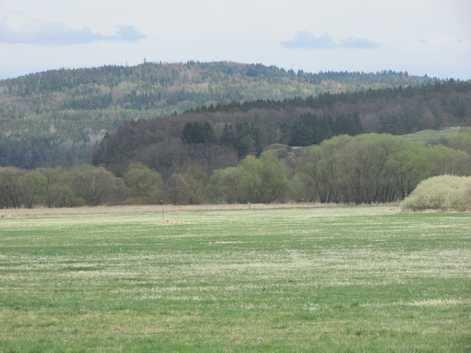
[0,63,471,208]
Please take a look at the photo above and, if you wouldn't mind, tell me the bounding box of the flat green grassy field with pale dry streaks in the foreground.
[0,207,471,353]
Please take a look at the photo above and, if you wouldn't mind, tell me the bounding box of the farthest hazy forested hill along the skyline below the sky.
[0,62,435,168]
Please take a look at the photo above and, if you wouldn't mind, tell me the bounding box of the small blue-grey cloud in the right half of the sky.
[281,31,379,49]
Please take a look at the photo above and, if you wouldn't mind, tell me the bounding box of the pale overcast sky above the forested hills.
[0,0,471,79]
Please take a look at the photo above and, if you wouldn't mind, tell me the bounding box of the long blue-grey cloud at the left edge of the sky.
[0,19,145,45]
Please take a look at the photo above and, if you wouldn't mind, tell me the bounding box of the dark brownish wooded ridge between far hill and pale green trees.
[94,81,471,177]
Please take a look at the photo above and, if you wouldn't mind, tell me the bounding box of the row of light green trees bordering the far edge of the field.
[0,134,471,208]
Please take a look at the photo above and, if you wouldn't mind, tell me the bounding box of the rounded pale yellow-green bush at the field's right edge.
[401,175,471,211]
